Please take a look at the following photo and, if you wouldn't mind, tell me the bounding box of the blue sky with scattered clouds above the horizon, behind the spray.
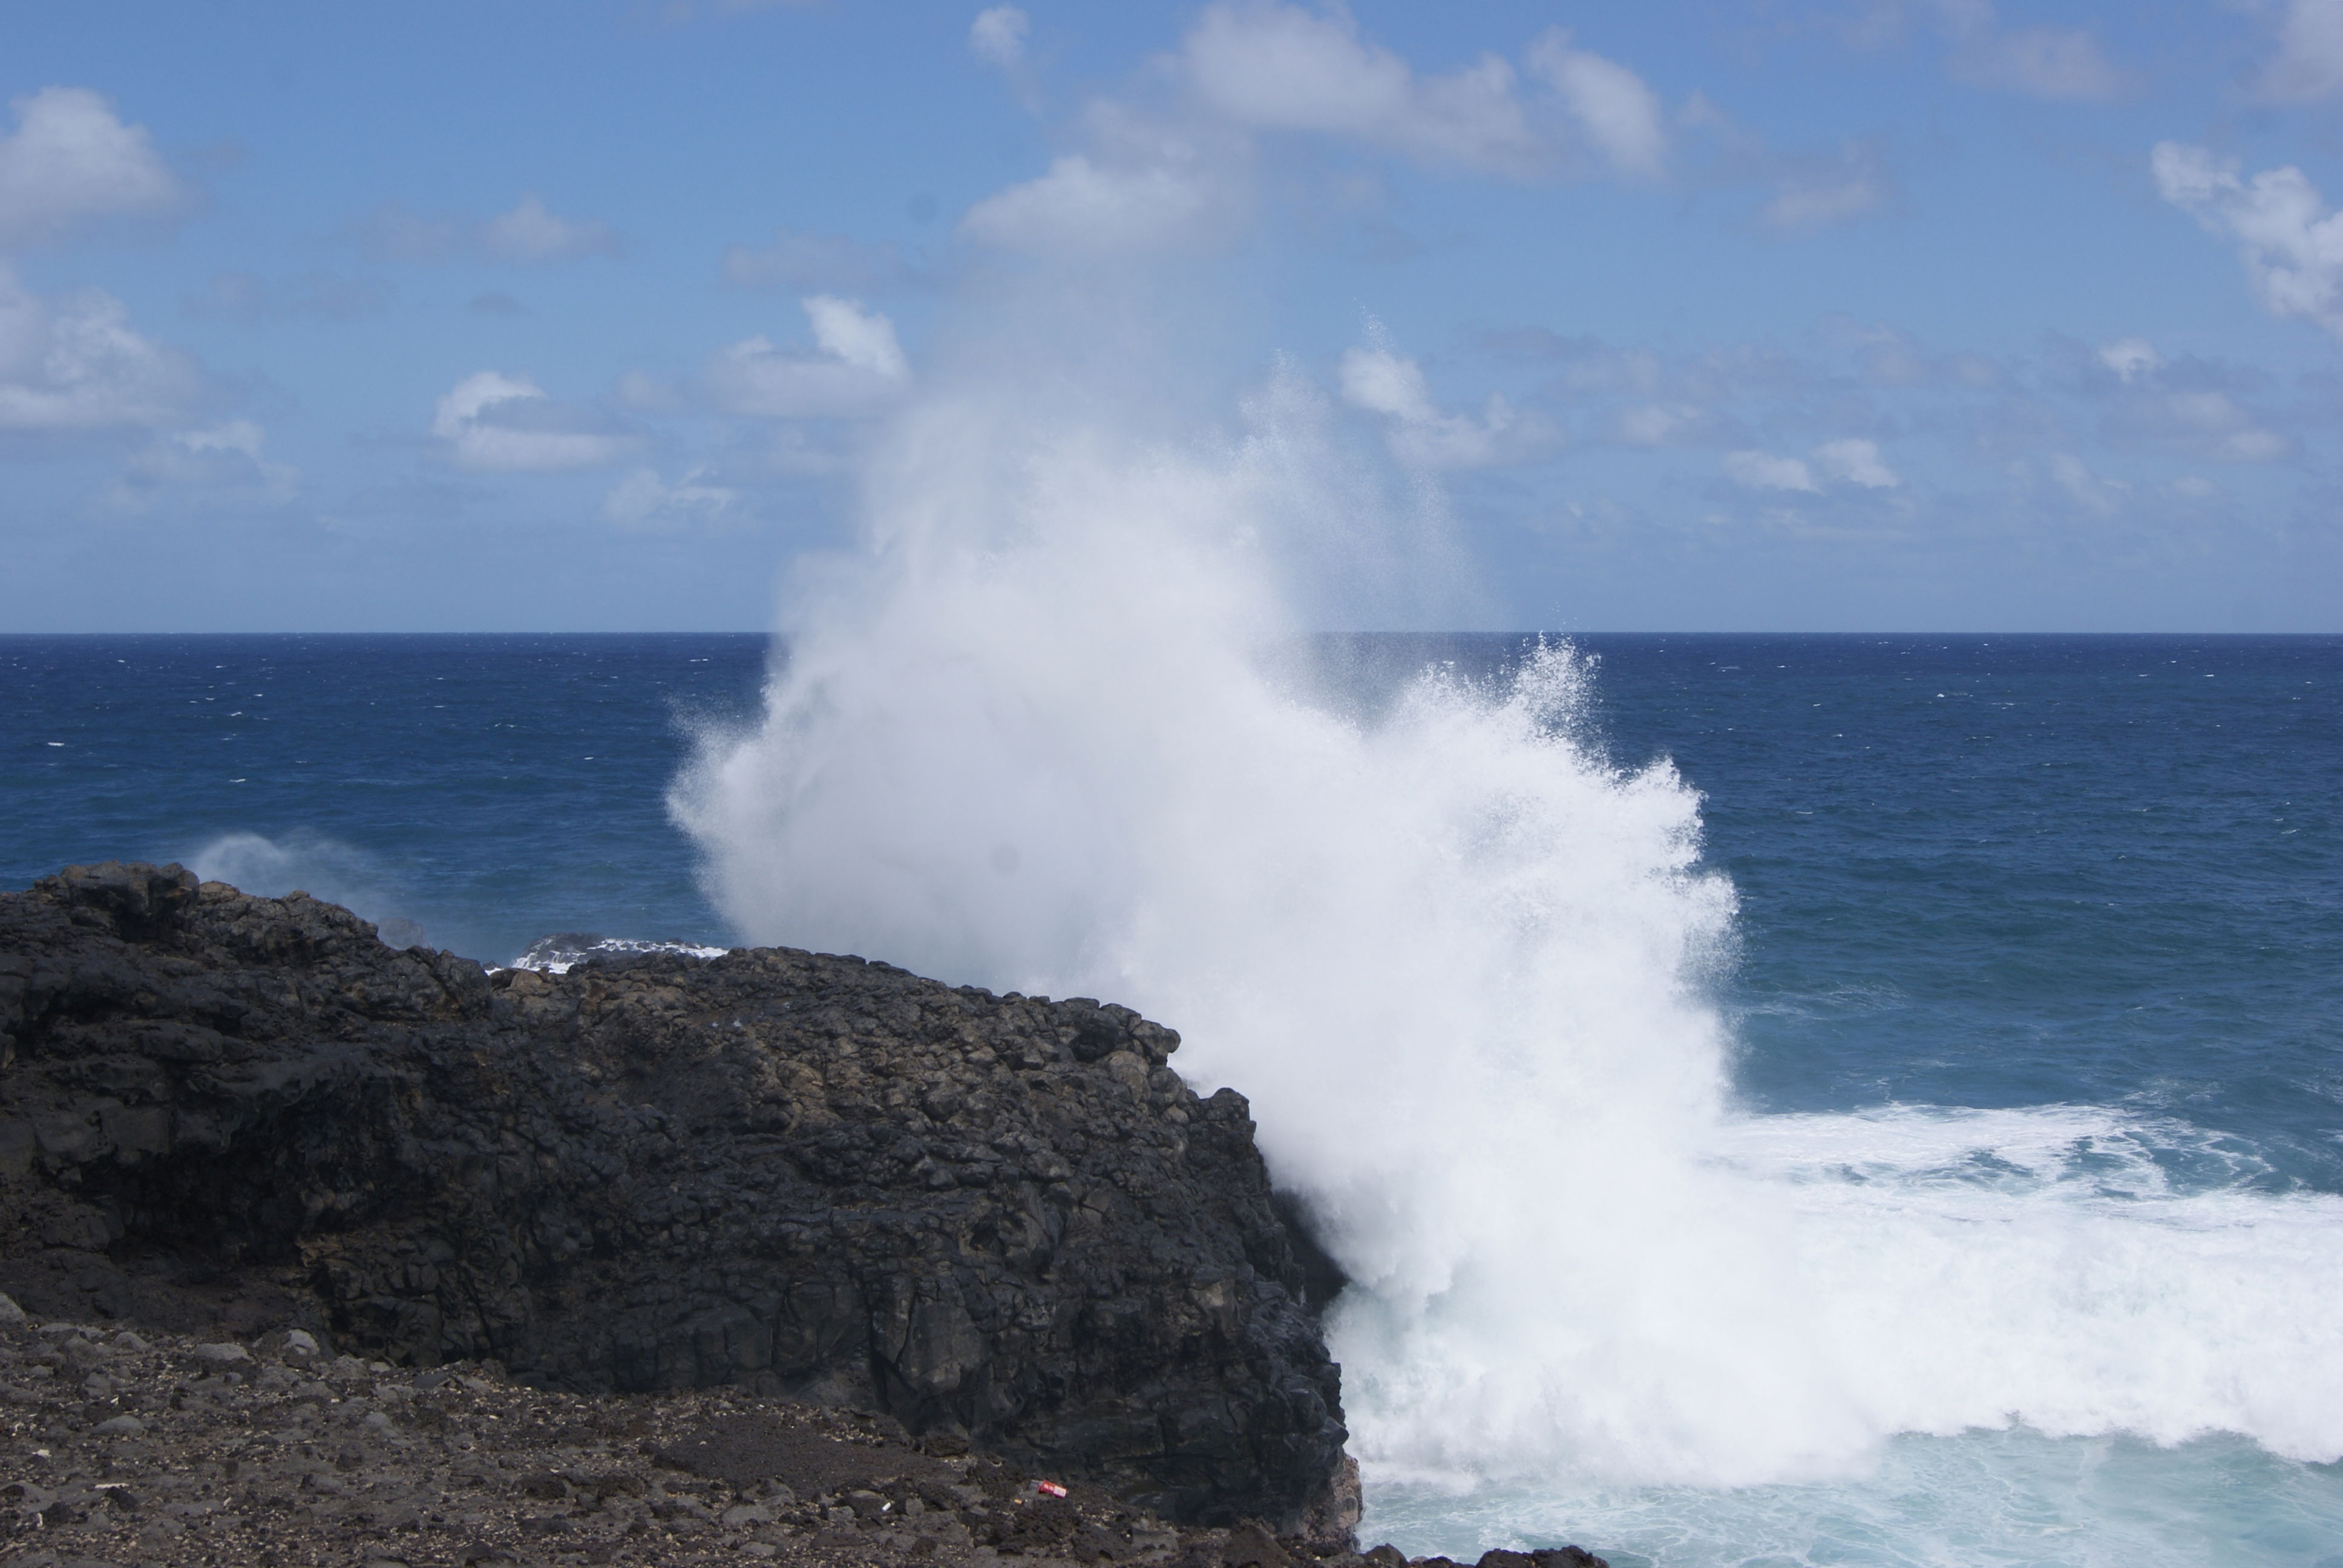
[0,0,2343,630]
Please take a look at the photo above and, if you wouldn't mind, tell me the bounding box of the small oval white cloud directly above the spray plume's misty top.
[961,152,1221,255]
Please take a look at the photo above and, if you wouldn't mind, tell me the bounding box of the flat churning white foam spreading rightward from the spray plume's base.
[1335,1106,2343,1486]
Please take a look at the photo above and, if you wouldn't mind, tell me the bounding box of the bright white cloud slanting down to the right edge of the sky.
[2151,140,2343,338]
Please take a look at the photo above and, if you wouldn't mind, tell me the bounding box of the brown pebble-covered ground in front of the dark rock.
[0,1296,1601,1568]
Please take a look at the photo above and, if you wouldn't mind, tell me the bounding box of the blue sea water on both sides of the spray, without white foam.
[0,635,2343,1568]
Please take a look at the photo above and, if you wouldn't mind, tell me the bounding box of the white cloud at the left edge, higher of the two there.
[0,87,188,249]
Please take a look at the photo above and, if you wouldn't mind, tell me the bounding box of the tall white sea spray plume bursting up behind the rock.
[675,330,1780,1481]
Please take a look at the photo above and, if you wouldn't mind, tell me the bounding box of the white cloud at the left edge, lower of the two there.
[0,263,204,431]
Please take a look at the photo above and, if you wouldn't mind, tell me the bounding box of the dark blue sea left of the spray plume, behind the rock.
[0,635,766,963]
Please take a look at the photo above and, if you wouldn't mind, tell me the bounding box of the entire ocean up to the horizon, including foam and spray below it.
[0,621,2343,1568]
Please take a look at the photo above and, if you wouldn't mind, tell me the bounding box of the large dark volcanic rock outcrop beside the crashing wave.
[0,865,1354,1528]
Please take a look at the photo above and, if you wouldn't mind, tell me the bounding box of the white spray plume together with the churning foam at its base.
[672,339,2343,1486]
